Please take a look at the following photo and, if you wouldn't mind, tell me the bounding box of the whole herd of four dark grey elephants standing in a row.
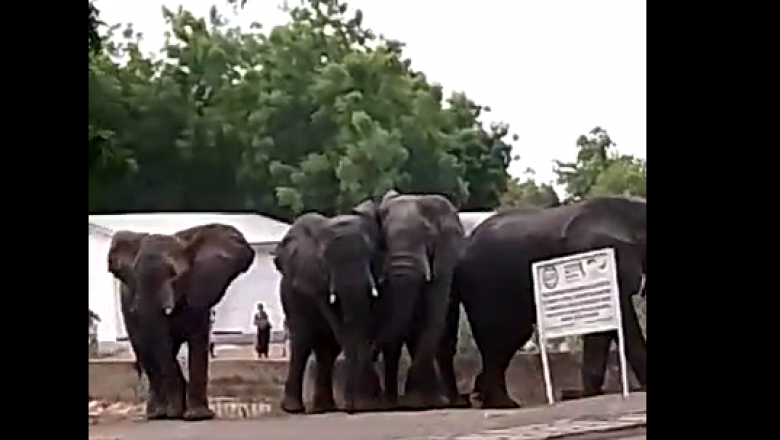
[108,191,647,420]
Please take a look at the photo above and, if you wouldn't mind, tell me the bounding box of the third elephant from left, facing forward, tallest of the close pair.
[356,191,465,409]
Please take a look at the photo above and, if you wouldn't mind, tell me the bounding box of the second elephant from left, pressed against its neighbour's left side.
[274,213,381,413]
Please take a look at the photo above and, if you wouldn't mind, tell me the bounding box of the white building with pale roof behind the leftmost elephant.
[89,213,290,341]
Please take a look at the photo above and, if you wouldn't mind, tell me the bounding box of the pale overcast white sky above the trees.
[96,0,647,185]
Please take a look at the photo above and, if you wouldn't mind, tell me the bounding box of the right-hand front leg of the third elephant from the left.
[405,279,450,409]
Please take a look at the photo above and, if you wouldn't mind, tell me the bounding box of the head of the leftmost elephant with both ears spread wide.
[108,224,254,315]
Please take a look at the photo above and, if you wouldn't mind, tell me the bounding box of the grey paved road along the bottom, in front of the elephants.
[90,393,646,440]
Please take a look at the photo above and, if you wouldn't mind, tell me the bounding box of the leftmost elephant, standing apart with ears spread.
[108,223,255,420]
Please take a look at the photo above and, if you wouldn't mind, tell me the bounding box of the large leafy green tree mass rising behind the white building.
[90,0,511,219]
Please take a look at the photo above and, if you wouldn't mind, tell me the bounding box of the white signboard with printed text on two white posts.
[531,248,628,404]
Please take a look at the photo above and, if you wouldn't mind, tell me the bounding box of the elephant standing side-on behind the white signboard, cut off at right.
[440,196,647,408]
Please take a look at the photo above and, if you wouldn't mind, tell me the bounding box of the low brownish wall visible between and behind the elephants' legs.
[89,352,636,405]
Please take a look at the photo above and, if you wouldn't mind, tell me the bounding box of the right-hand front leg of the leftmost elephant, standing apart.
[184,311,215,421]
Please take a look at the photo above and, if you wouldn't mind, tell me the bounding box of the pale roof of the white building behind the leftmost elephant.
[89,212,290,244]
